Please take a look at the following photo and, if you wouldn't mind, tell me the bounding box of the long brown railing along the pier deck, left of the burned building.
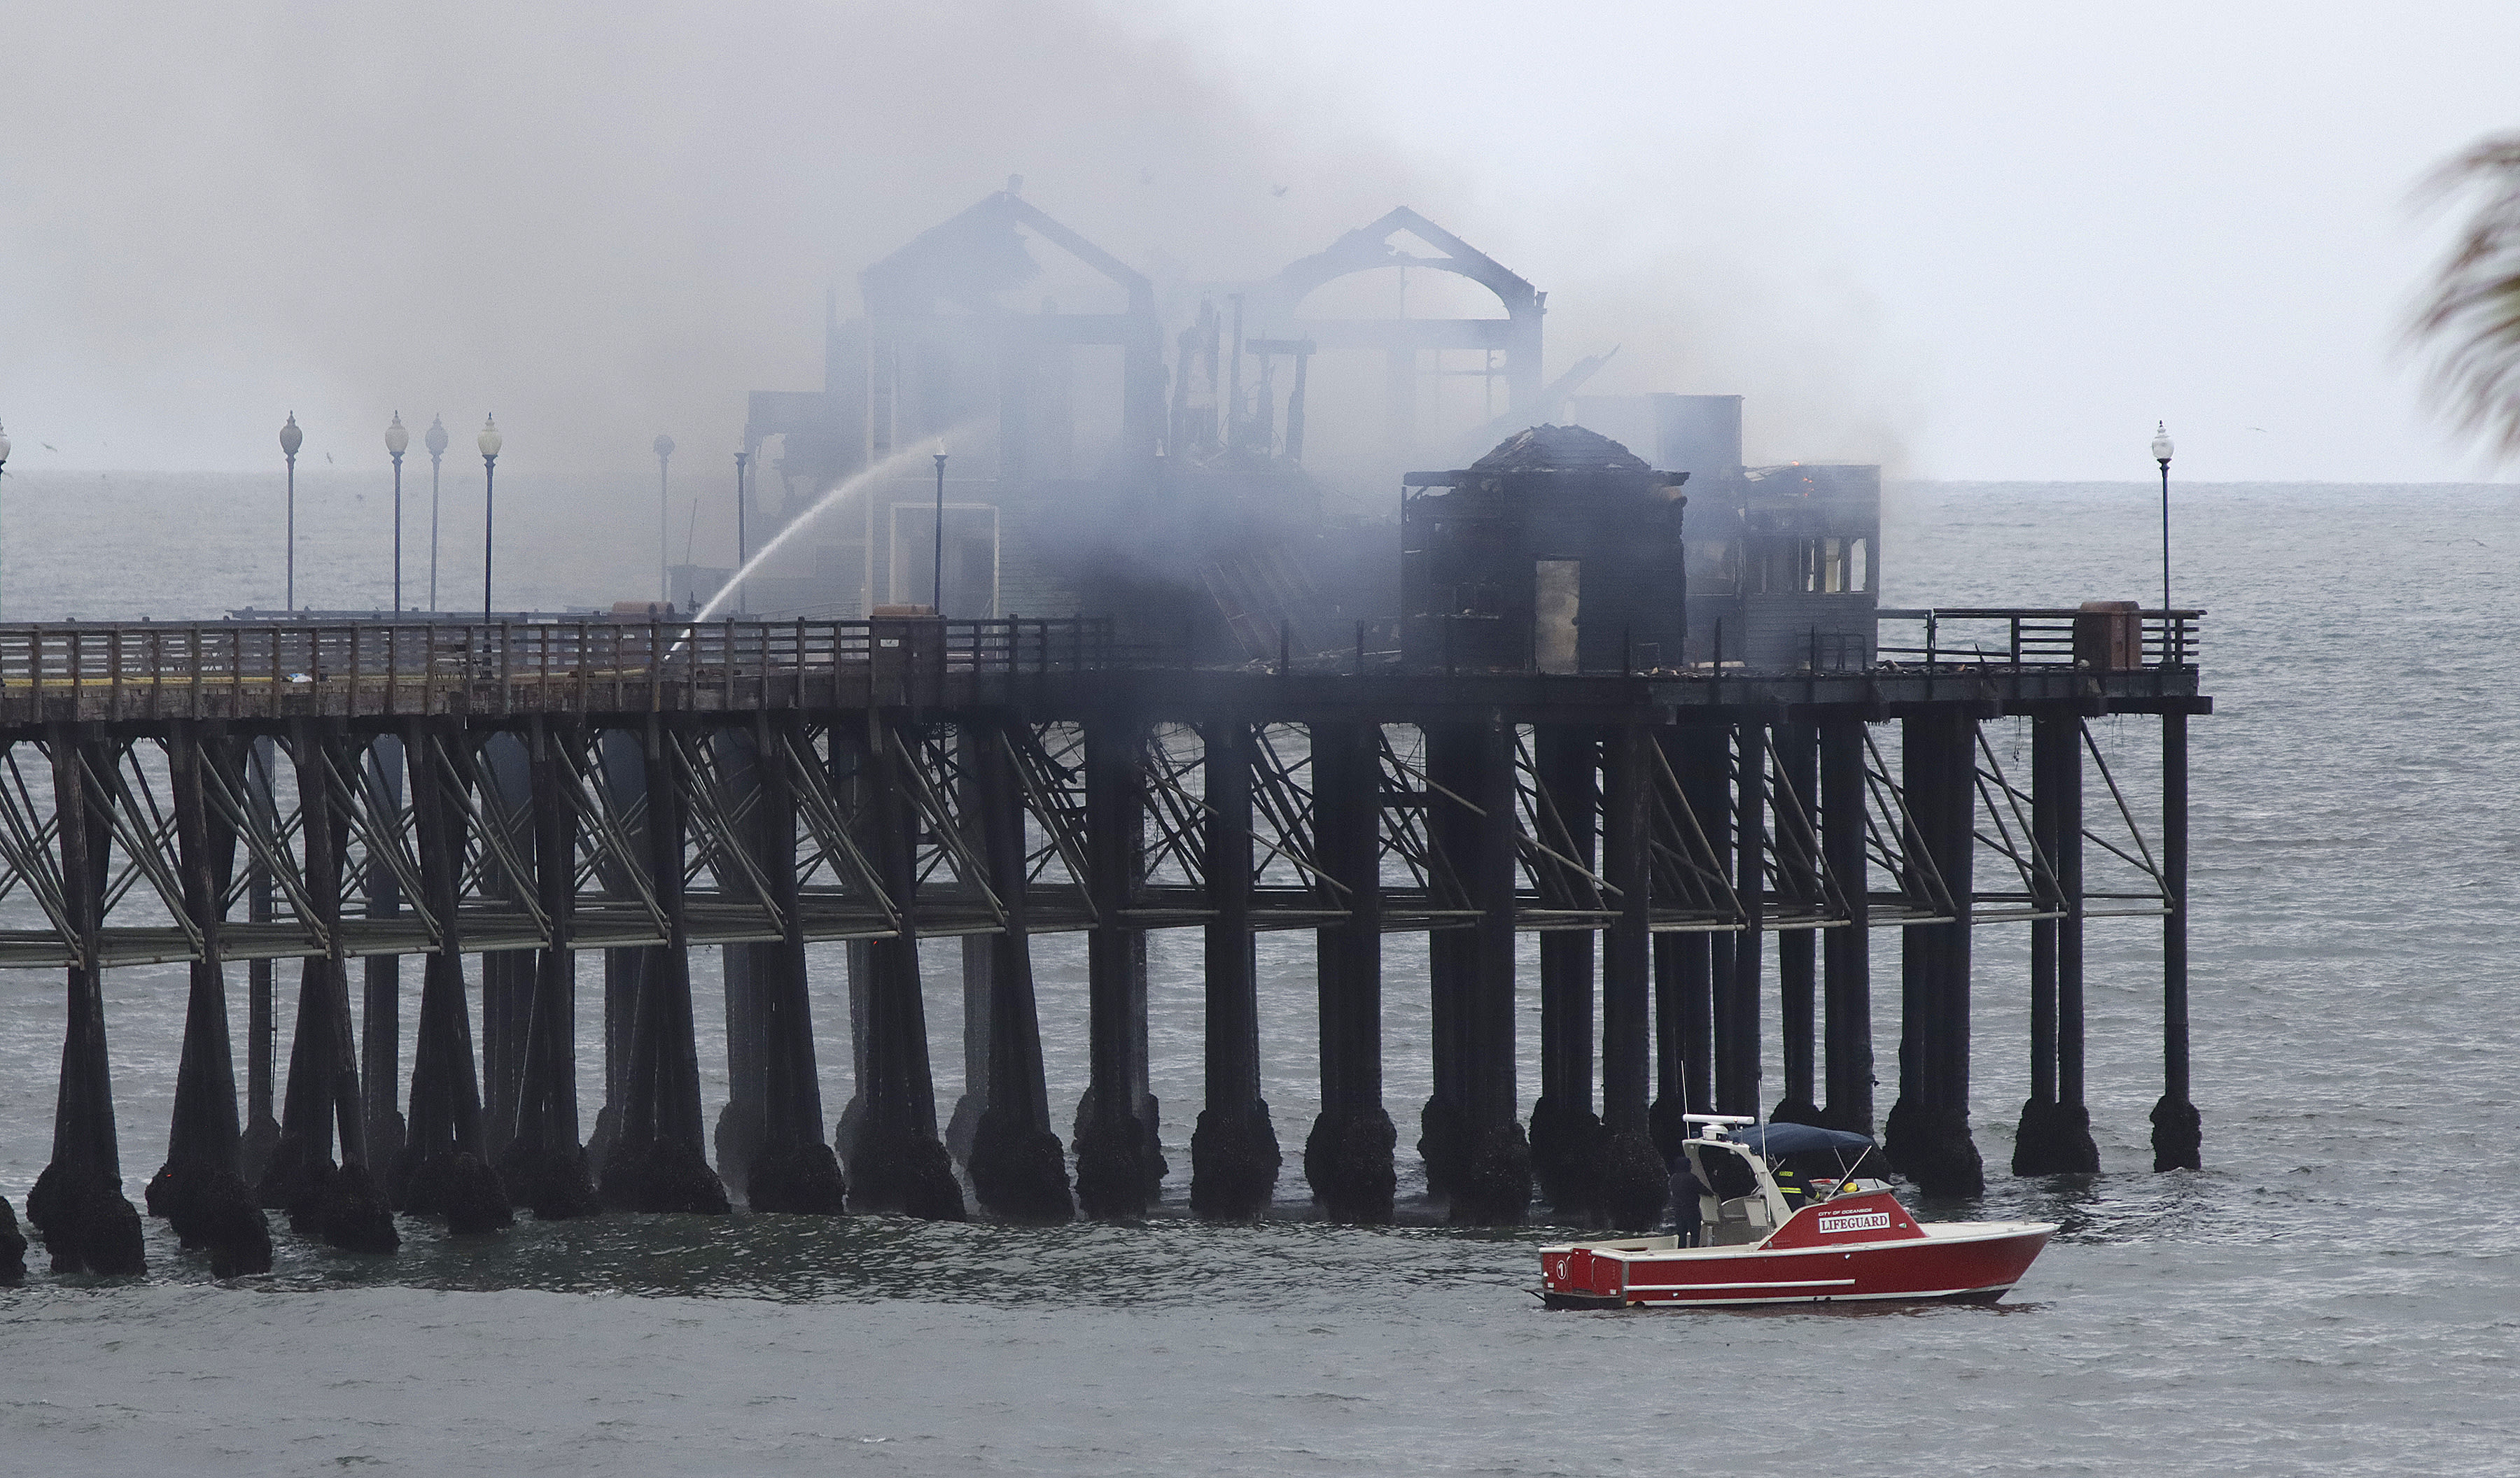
[0,617,1129,720]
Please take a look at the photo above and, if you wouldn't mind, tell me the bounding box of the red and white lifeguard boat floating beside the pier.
[1540,1113,2057,1309]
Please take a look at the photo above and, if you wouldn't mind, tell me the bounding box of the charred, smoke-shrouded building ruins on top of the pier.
[720,178,1880,670]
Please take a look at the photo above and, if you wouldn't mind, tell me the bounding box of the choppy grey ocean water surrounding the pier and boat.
[0,479,2520,1475]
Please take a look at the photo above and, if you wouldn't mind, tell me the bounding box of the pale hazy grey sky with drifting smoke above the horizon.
[0,0,2520,481]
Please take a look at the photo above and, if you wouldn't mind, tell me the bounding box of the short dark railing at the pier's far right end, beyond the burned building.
[1875,607,2205,673]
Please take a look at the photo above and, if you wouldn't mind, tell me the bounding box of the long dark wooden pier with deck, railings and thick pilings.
[0,610,2210,1272]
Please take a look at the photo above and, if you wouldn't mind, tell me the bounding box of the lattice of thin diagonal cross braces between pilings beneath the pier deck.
[0,710,2167,967]
